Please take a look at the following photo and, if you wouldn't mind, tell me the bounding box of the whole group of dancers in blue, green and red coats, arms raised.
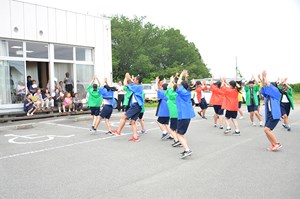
[87,70,294,158]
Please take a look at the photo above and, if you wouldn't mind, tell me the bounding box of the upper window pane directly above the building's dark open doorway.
[26,42,48,59]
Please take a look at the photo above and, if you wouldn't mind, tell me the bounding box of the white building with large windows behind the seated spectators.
[0,0,112,113]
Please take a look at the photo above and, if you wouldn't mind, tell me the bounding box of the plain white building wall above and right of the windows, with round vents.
[0,0,112,79]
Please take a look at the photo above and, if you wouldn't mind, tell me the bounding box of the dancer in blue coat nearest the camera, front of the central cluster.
[176,70,195,158]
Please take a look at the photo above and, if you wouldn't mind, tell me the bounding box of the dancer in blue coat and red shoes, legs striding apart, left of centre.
[112,73,144,141]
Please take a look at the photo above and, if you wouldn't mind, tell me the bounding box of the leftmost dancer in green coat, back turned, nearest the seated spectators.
[86,76,102,132]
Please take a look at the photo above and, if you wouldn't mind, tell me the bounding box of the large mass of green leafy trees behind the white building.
[111,16,211,83]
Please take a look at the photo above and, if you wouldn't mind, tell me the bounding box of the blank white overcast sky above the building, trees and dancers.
[23,0,300,83]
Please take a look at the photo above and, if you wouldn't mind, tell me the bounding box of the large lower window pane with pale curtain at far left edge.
[0,60,26,104]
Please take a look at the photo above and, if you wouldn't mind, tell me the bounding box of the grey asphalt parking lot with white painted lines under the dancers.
[0,106,300,199]
